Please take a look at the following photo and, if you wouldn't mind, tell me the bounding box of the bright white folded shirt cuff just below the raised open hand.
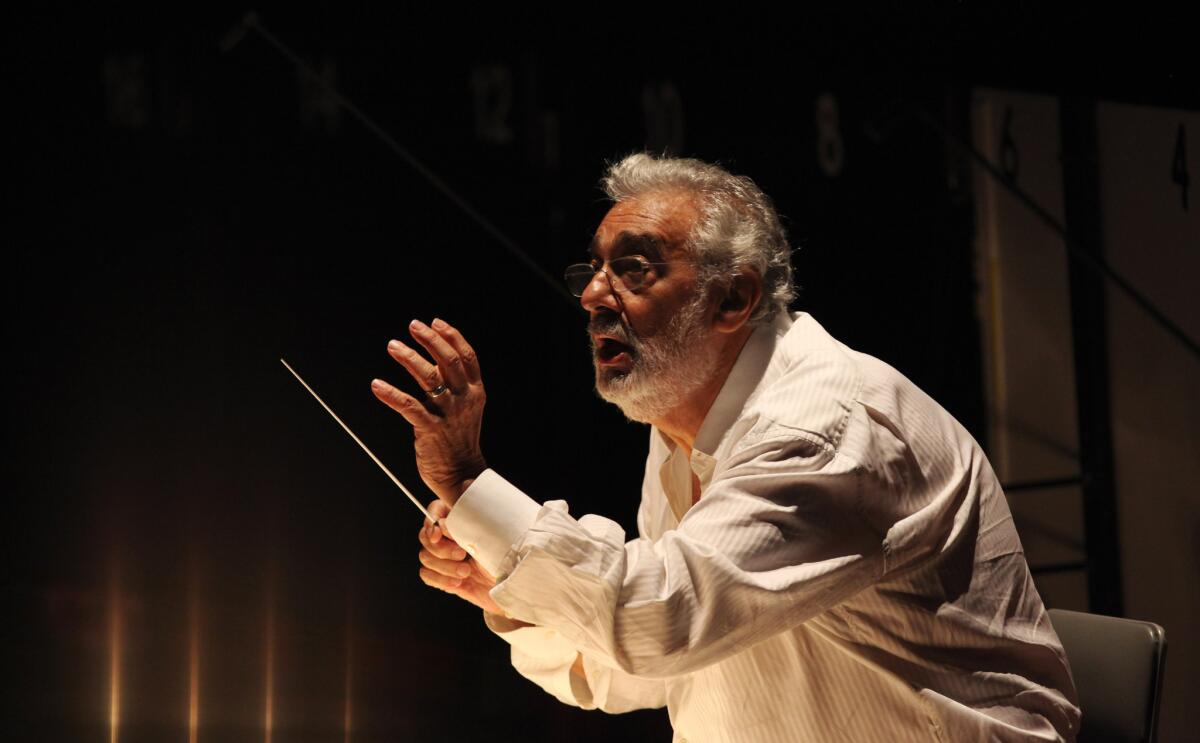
[445,469,541,581]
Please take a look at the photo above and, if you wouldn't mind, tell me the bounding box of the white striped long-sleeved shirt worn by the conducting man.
[448,313,1079,743]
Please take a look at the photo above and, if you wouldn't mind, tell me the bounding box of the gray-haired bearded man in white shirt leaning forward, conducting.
[372,155,1079,742]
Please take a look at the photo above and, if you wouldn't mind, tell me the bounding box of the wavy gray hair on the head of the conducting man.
[601,152,796,324]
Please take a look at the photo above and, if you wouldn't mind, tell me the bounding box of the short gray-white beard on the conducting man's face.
[588,292,718,423]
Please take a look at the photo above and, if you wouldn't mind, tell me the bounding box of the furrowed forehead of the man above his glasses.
[589,191,700,258]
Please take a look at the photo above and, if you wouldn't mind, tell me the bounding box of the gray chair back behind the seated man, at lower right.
[1050,609,1166,743]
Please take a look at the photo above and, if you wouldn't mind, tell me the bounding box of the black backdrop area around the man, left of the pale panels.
[4,4,1196,741]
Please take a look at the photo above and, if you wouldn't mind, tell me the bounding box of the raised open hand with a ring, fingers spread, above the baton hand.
[371,319,487,505]
